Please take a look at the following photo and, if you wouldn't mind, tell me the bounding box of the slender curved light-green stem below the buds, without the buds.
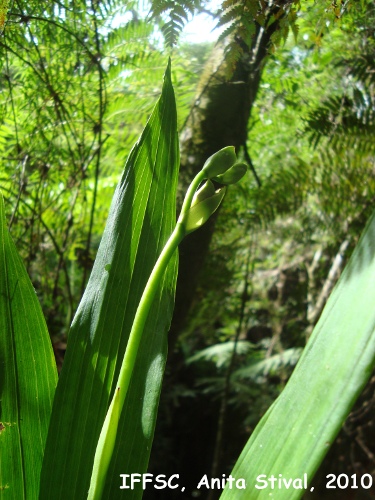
[87,171,206,500]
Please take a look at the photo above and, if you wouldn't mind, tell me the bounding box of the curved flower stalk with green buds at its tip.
[88,146,246,500]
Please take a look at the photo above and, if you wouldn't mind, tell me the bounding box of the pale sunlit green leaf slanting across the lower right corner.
[221,213,375,500]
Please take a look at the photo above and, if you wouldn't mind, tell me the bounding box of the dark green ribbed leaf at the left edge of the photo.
[0,193,57,500]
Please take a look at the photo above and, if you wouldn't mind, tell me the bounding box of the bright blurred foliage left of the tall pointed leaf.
[0,2,204,347]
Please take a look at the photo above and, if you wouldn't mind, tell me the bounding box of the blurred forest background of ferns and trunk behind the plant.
[0,0,375,499]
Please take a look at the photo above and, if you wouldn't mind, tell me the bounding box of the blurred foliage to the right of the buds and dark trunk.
[148,3,375,488]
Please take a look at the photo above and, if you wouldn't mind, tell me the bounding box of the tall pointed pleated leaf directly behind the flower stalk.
[40,59,179,500]
